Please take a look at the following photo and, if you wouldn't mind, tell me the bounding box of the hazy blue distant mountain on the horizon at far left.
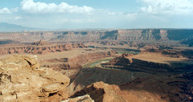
[0,23,37,32]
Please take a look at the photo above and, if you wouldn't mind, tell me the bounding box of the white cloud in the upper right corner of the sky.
[141,0,193,14]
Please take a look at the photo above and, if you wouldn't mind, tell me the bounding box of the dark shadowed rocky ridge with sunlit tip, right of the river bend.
[101,54,172,72]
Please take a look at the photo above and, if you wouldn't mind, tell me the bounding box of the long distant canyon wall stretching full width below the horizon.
[0,29,193,42]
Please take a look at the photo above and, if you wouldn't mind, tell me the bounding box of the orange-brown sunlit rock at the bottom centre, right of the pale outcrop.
[72,82,167,102]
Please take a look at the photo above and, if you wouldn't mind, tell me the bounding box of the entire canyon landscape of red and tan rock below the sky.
[0,29,193,102]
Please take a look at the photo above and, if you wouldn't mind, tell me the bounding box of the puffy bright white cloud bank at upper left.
[21,0,94,13]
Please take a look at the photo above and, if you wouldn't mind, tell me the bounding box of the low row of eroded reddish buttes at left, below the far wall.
[0,42,86,55]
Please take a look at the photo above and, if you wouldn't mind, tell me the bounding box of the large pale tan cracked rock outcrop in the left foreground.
[0,55,70,102]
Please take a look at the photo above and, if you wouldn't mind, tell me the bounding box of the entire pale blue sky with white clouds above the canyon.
[0,0,193,29]
